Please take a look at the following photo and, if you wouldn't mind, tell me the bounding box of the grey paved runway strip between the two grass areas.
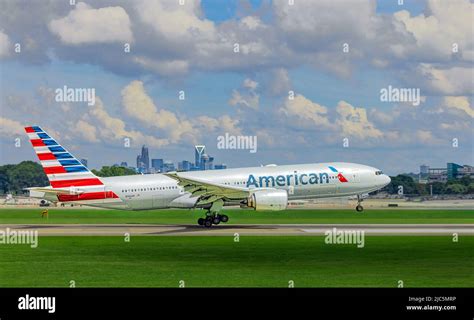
[0,224,474,236]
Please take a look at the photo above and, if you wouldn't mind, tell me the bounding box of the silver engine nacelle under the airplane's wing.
[247,189,288,211]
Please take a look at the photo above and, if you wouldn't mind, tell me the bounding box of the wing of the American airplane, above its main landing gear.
[165,173,250,205]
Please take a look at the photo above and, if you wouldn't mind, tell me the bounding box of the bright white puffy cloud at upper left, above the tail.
[48,2,133,45]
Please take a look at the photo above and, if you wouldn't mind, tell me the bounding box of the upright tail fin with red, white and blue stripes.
[25,126,103,188]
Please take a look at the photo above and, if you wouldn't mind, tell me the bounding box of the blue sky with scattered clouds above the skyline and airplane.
[0,0,474,174]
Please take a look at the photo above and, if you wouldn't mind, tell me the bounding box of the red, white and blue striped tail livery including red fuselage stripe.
[25,126,118,202]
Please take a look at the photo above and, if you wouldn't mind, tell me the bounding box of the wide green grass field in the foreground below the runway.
[0,236,474,287]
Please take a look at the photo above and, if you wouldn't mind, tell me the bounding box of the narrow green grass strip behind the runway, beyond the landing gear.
[0,208,474,224]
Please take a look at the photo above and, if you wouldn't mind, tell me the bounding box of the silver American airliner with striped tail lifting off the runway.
[25,126,390,228]
